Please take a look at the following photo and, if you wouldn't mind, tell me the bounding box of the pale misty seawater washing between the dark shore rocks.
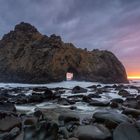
[0,80,140,113]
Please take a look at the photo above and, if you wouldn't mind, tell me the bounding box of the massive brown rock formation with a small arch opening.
[0,22,127,83]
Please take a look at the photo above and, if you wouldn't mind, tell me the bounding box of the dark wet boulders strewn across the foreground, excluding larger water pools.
[0,85,140,140]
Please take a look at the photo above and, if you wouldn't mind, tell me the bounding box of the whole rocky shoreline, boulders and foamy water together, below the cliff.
[0,81,140,140]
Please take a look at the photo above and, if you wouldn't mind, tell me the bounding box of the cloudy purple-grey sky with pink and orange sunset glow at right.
[0,0,140,77]
